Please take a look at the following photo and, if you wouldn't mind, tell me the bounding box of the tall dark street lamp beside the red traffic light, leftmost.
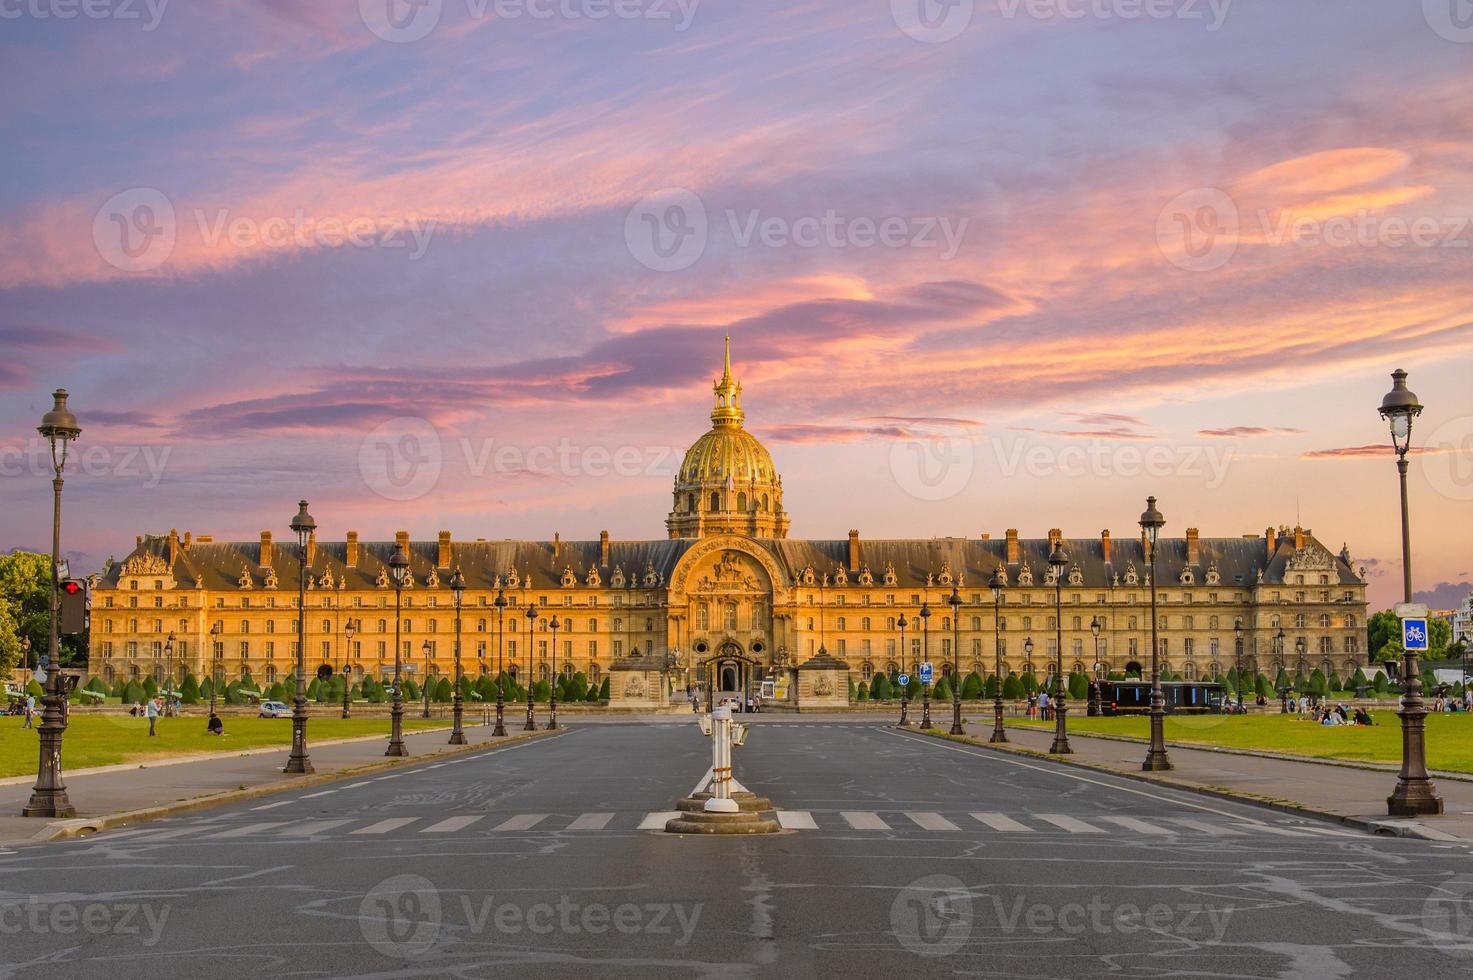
[21,388,82,816]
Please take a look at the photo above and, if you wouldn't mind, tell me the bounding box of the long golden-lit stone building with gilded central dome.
[90,343,1367,691]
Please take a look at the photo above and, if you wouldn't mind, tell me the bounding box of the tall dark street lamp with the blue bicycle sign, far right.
[1379,368,1442,816]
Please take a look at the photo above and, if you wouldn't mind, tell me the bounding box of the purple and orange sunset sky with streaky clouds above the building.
[0,0,1473,609]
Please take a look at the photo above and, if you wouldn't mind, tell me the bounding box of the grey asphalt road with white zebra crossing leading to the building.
[0,719,1473,979]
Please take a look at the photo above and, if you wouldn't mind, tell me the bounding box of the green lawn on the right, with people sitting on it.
[1009,710,1473,772]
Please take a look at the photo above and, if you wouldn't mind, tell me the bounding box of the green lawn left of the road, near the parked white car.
[0,712,451,777]
